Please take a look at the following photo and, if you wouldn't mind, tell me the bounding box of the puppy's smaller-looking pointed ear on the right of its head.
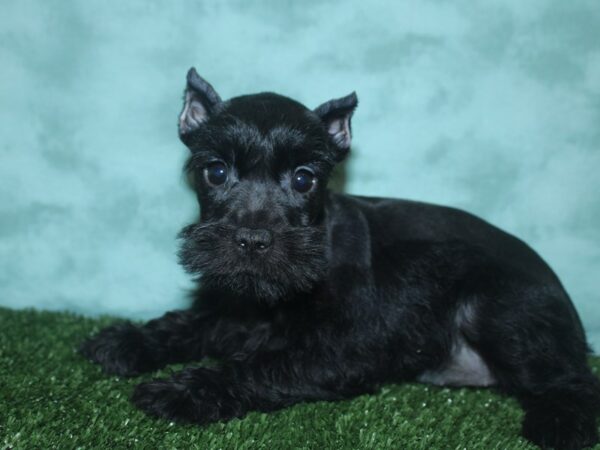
[315,92,358,153]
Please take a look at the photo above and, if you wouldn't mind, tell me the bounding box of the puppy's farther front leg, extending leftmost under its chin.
[79,310,209,376]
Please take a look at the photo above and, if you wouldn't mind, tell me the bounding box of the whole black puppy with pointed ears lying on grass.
[82,69,600,448]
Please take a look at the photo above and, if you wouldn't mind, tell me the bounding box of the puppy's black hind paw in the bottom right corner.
[523,411,598,450]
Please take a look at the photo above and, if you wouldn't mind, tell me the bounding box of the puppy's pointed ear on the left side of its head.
[179,67,221,139]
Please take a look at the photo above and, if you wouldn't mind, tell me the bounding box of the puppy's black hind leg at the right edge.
[461,278,600,449]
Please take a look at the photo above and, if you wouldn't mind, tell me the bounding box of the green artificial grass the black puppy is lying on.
[0,308,600,450]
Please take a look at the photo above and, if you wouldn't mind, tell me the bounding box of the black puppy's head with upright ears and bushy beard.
[179,69,357,304]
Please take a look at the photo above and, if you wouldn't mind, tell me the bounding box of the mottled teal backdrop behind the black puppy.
[0,0,600,344]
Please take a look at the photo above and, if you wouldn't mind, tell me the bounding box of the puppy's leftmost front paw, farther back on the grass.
[79,322,161,376]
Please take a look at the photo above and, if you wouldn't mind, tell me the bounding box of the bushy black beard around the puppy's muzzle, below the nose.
[179,223,326,304]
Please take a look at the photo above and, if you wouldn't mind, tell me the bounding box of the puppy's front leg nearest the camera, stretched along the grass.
[133,342,374,424]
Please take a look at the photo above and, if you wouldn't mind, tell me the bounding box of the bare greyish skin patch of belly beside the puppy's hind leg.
[417,337,496,386]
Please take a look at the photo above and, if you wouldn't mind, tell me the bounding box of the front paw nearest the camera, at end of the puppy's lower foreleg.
[132,368,243,424]
